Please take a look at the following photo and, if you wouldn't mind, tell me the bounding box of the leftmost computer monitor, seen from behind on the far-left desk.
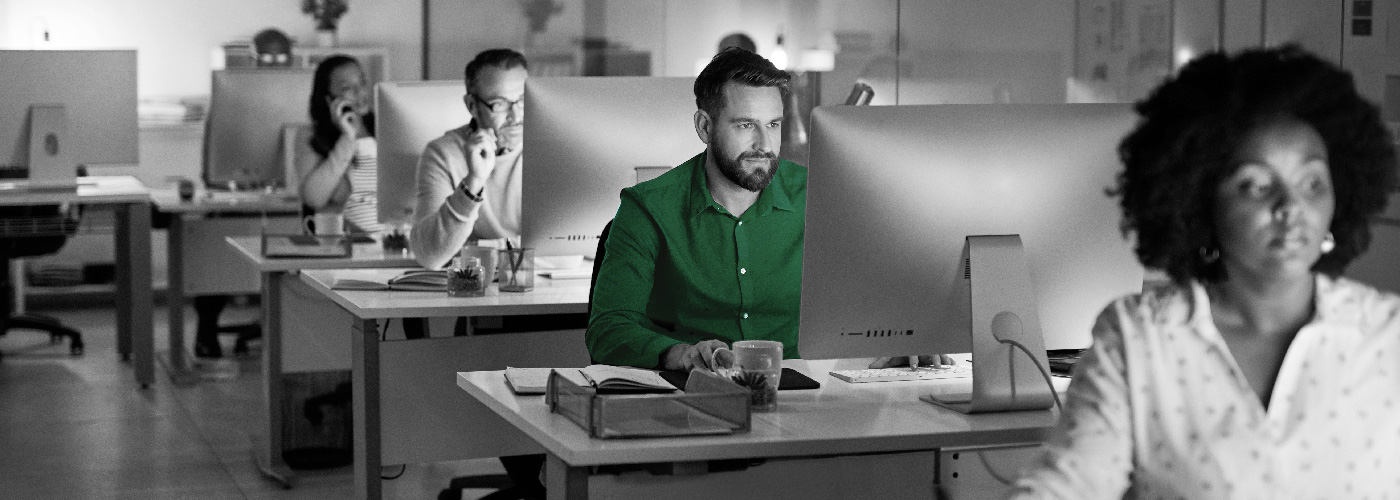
[0,50,139,179]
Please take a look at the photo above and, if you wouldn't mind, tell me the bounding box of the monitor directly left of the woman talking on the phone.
[204,67,314,188]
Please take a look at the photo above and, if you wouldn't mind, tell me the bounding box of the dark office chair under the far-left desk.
[0,204,83,356]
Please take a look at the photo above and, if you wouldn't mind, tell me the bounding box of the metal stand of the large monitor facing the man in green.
[923,234,1054,413]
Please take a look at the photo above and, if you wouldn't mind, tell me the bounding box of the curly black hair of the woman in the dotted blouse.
[1110,45,1396,283]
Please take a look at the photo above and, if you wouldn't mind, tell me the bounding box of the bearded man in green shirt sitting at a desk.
[587,48,806,370]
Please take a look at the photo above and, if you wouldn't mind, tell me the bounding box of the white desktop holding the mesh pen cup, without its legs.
[301,269,588,319]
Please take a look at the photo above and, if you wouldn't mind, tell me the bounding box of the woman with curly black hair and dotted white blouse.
[1014,46,1400,499]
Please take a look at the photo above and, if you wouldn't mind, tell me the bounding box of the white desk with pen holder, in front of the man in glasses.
[301,269,588,499]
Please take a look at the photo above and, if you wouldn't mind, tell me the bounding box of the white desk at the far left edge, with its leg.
[0,175,155,388]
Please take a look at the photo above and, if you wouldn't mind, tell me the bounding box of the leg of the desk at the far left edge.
[112,202,155,389]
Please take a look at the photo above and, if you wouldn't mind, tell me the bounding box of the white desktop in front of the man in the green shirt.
[456,360,1064,466]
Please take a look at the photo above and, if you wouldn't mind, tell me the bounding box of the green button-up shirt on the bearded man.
[585,153,806,368]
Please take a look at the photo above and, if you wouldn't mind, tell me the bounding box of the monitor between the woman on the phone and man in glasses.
[374,80,472,224]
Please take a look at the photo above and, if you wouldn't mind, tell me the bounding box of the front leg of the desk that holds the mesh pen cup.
[350,318,384,500]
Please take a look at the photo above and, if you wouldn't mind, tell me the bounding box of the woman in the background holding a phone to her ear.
[297,55,381,232]
